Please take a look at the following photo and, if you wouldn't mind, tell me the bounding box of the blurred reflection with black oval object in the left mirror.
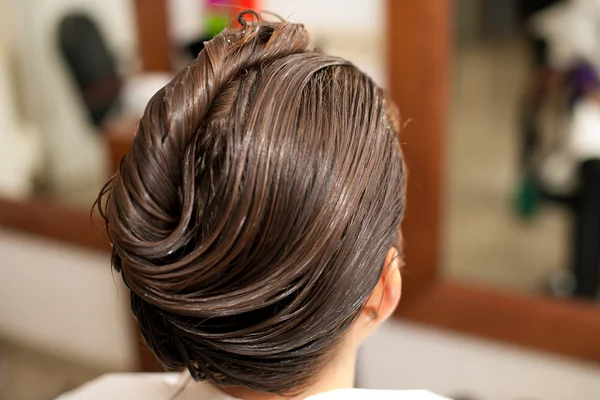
[0,0,171,209]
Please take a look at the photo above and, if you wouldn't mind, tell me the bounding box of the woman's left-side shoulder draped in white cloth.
[56,373,221,400]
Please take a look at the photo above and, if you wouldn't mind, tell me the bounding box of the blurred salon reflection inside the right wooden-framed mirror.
[444,0,600,299]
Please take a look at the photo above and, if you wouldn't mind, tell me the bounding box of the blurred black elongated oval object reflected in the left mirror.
[58,14,122,127]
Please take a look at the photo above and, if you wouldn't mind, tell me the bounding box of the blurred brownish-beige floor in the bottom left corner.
[0,340,106,400]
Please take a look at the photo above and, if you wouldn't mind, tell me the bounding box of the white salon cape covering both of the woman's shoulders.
[56,373,448,400]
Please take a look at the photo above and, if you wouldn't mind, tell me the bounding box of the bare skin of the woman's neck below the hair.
[220,351,356,400]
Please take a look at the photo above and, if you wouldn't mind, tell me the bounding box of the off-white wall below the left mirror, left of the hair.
[0,229,135,370]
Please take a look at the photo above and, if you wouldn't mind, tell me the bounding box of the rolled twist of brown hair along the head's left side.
[103,11,309,259]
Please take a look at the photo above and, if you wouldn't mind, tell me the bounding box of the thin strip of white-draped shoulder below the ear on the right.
[306,389,450,400]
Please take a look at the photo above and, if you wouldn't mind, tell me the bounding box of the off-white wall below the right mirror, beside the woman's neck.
[358,322,600,400]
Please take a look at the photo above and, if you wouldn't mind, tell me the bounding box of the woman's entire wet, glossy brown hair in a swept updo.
[95,12,405,394]
